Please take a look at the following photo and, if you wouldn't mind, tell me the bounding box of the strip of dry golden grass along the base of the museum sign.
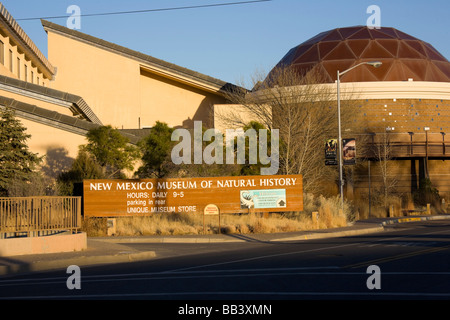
[84,195,352,236]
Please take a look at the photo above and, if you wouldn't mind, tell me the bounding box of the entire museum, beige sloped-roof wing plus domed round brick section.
[0,5,450,202]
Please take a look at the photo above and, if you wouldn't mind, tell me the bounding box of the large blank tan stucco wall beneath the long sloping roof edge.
[48,30,227,129]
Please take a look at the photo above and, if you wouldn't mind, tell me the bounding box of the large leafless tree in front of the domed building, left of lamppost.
[218,68,357,192]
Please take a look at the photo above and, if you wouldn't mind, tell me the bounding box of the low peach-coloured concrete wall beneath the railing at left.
[0,232,87,257]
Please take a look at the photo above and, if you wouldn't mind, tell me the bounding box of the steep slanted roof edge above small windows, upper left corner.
[0,2,56,79]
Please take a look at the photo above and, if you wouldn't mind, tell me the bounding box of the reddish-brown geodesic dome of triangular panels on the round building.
[269,26,450,82]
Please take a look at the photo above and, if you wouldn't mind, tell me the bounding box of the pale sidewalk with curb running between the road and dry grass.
[0,215,450,276]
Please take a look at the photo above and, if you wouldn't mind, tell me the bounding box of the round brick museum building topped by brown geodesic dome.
[250,26,450,199]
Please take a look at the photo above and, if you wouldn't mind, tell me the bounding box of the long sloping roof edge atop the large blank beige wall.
[41,20,241,92]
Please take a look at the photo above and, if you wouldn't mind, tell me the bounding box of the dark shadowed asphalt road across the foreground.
[0,220,450,301]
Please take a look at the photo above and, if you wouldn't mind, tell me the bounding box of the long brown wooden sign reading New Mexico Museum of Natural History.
[83,175,303,217]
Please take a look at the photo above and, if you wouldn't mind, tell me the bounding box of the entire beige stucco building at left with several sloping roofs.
[0,4,234,176]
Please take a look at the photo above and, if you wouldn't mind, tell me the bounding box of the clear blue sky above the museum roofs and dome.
[2,0,450,83]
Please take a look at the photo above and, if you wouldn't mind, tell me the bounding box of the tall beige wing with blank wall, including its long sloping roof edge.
[42,21,229,129]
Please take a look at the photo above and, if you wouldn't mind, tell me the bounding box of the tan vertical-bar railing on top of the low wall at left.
[0,197,81,237]
